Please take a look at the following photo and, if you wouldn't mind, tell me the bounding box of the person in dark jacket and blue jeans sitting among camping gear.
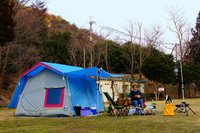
[130,84,144,111]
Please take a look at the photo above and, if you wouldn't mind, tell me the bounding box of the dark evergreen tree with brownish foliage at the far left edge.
[0,0,16,89]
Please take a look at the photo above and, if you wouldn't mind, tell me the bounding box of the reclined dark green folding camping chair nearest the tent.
[103,92,128,117]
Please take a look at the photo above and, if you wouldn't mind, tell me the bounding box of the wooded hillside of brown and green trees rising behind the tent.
[0,0,200,105]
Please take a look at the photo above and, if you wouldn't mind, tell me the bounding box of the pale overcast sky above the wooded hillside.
[46,0,200,54]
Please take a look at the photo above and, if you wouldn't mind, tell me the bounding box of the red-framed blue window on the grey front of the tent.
[44,88,64,107]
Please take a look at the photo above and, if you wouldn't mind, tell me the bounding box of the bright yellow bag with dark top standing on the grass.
[164,96,174,116]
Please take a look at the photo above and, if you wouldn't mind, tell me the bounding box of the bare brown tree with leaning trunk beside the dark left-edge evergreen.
[0,0,46,90]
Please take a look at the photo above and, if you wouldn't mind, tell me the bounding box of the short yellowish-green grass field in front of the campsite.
[0,99,200,133]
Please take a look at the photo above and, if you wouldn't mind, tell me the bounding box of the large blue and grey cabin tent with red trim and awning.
[8,62,126,116]
